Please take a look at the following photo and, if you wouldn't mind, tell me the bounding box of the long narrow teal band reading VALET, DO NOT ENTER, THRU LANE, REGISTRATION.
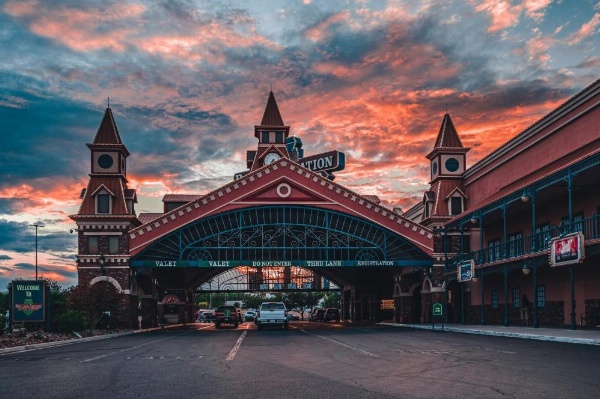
[131,260,433,268]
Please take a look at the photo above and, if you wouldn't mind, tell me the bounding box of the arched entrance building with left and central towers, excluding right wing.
[71,93,434,325]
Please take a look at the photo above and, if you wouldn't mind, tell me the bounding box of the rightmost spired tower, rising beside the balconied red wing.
[421,113,470,227]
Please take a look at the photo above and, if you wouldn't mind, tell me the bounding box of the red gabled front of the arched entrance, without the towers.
[129,159,432,319]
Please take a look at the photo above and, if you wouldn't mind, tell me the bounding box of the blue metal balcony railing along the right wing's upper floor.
[445,215,600,273]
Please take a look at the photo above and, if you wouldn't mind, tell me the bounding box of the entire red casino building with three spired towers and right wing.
[71,81,600,329]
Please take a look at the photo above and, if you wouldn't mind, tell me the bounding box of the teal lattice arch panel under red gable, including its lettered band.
[131,205,432,268]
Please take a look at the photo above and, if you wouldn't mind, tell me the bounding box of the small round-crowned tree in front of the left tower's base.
[68,282,120,330]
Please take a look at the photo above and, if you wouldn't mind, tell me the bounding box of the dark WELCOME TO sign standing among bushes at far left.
[11,280,46,322]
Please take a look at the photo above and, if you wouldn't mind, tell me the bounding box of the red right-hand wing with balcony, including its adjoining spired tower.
[400,76,600,329]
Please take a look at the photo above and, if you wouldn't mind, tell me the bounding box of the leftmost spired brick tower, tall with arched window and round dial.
[70,107,140,304]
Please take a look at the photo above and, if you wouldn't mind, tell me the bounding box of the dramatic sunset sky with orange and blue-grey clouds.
[0,0,600,291]
